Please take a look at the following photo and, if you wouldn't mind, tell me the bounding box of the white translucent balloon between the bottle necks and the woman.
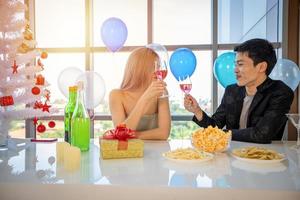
[76,71,105,109]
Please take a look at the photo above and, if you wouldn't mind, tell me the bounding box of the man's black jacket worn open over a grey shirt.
[193,78,294,143]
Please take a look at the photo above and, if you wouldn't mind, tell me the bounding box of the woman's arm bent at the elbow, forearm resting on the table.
[138,98,171,140]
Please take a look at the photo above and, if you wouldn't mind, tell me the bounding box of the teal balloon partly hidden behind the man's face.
[214,52,237,88]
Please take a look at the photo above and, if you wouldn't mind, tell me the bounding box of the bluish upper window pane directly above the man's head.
[218,0,281,43]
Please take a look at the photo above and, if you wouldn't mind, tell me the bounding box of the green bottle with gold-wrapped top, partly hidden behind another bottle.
[64,86,77,144]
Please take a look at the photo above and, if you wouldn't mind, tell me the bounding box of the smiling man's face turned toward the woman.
[234,52,260,86]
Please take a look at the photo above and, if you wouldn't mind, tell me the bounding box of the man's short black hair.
[234,38,276,76]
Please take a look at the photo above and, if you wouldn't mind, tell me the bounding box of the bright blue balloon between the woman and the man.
[170,48,197,81]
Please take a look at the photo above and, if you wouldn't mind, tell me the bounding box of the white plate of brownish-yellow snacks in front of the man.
[232,146,285,163]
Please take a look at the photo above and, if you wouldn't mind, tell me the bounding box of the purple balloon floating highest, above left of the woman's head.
[101,17,128,52]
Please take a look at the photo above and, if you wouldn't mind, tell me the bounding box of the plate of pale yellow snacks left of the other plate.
[162,148,214,163]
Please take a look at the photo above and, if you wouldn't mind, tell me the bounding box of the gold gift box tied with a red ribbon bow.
[99,125,144,159]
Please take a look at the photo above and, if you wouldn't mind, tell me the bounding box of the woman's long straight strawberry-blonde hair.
[121,47,159,90]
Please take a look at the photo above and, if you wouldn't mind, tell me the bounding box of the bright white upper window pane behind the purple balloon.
[93,0,147,46]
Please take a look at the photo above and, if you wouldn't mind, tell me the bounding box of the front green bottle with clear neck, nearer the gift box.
[71,82,90,151]
